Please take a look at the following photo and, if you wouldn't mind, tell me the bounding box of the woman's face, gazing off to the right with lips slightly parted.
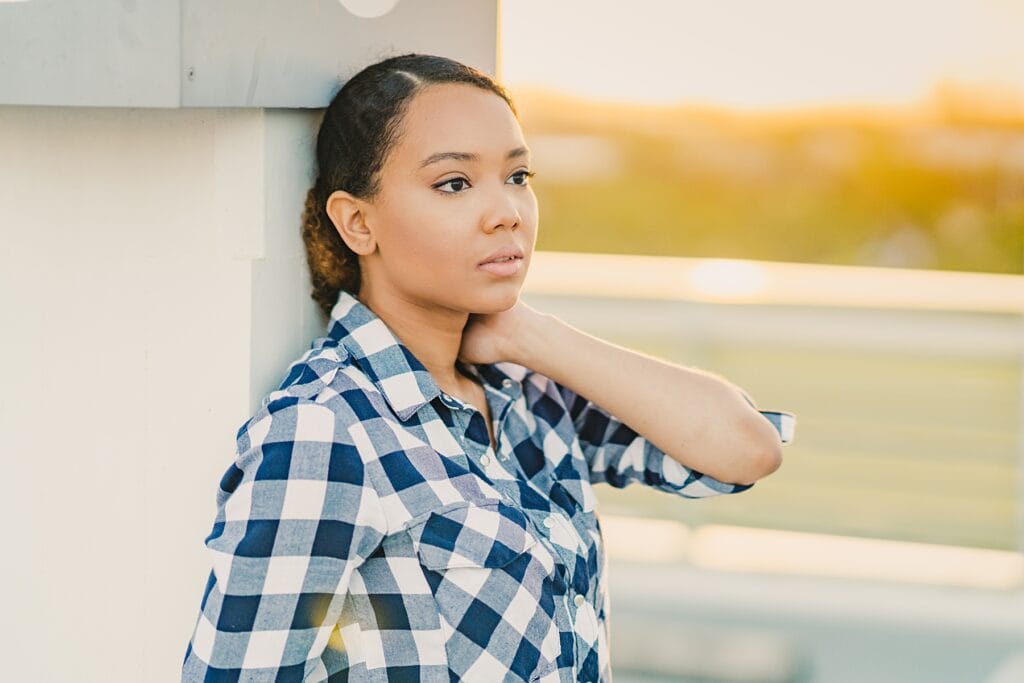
[361,84,538,313]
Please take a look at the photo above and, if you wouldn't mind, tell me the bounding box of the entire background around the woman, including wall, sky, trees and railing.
[0,0,1024,683]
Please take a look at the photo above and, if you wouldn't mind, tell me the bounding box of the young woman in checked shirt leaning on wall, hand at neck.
[182,54,793,683]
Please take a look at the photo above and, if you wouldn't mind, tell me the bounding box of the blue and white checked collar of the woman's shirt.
[327,290,525,422]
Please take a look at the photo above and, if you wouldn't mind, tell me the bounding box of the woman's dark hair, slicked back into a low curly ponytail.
[302,53,519,318]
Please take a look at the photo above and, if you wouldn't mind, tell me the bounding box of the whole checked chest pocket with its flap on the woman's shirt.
[408,500,561,681]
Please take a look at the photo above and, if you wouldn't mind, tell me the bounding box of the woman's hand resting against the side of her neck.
[459,299,545,365]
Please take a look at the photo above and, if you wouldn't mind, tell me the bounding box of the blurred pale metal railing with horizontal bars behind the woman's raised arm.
[523,252,1024,683]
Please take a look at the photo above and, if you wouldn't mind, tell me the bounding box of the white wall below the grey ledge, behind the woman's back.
[0,106,323,682]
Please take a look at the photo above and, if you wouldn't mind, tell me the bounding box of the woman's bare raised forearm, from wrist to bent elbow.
[512,312,781,483]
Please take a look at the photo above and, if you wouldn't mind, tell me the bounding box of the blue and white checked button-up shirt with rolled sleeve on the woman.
[182,292,795,683]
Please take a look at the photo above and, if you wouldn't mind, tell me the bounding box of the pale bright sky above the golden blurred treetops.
[500,0,1024,109]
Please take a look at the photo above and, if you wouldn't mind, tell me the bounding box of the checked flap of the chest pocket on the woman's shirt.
[409,501,537,570]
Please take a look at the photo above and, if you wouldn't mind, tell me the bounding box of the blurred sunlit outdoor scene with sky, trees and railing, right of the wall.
[499,0,1024,683]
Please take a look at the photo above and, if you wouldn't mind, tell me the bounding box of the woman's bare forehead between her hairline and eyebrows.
[393,83,524,170]
